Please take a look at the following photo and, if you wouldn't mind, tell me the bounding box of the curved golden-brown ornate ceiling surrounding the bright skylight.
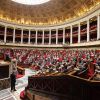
[0,0,100,25]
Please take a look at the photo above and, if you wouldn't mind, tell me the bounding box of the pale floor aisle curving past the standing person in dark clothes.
[0,68,35,100]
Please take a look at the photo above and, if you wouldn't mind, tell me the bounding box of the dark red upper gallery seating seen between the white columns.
[0,21,97,45]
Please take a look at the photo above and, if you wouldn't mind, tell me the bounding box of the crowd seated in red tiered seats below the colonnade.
[0,48,100,78]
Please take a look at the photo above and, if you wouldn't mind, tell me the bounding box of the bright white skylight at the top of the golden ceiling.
[12,0,50,5]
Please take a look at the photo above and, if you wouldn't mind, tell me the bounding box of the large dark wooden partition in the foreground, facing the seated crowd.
[27,75,100,100]
